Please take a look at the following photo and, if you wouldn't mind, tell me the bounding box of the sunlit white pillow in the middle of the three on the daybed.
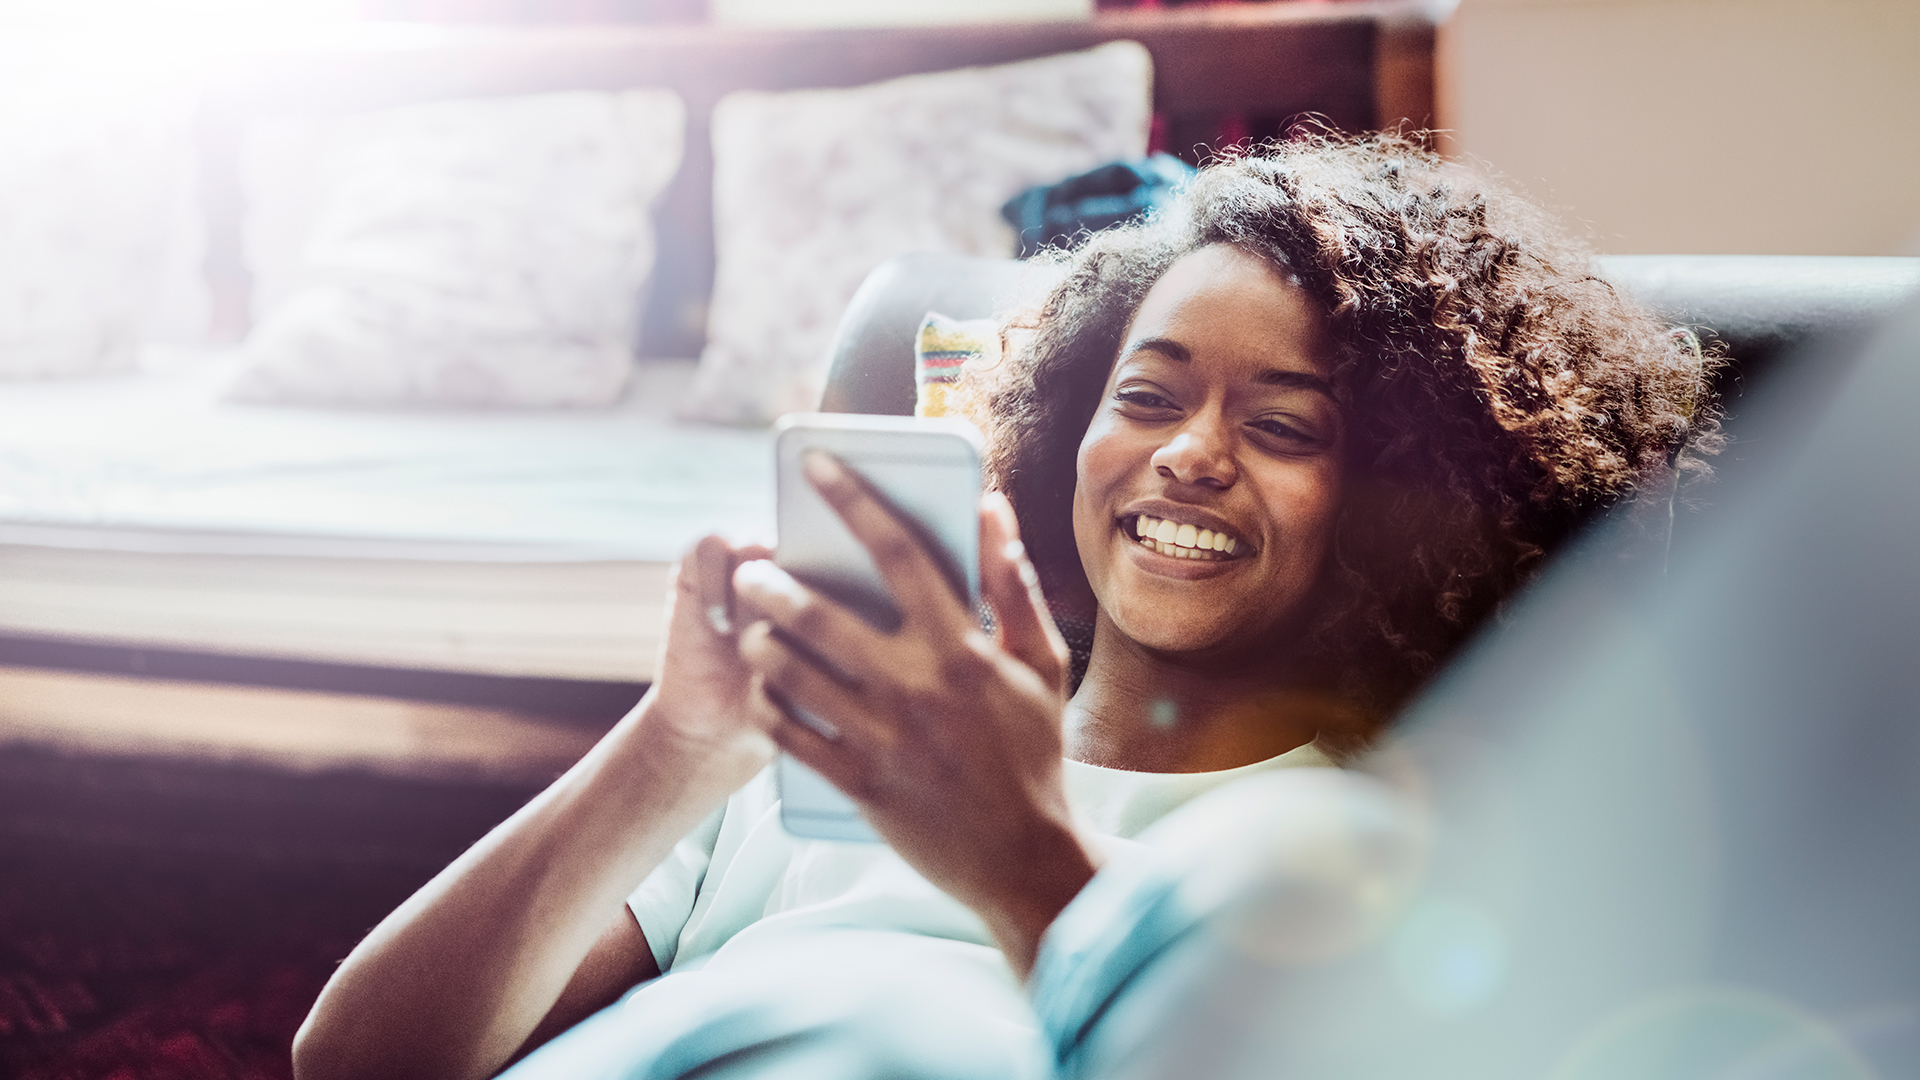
[227,90,685,405]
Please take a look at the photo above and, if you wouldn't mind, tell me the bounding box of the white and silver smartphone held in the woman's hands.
[774,413,981,842]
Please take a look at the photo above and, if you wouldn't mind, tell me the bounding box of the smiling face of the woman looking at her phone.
[1073,244,1342,657]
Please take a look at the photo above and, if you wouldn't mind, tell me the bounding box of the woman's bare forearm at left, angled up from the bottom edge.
[294,694,737,1080]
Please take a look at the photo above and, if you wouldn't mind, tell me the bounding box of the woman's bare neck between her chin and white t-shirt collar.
[1066,613,1334,773]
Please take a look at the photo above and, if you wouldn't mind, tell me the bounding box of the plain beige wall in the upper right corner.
[1440,0,1920,256]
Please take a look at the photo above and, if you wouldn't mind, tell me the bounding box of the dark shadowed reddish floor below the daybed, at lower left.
[0,749,534,1080]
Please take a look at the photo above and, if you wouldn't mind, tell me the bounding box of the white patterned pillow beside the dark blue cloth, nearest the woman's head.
[684,42,1152,423]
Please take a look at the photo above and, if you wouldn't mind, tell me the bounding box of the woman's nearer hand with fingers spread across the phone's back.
[733,454,1094,972]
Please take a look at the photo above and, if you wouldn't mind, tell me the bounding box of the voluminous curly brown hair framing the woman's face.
[977,135,1720,717]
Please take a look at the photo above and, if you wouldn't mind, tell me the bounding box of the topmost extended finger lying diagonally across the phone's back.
[801,450,973,634]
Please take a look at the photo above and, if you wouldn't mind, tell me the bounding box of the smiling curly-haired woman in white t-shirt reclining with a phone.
[296,136,1715,1078]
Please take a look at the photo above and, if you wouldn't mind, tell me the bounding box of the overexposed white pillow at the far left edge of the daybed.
[0,86,205,379]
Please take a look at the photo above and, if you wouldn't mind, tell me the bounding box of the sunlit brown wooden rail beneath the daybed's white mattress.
[0,667,601,784]
